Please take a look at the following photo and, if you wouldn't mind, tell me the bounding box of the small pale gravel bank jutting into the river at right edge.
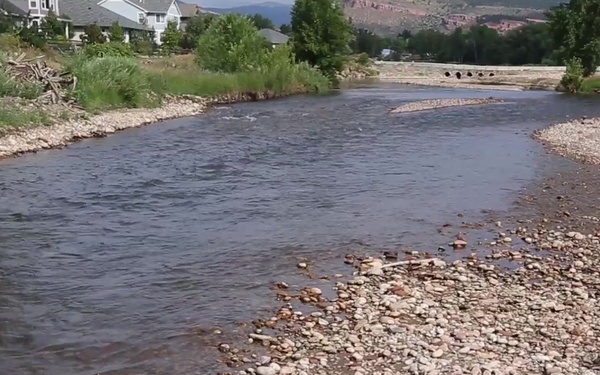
[534,118,600,164]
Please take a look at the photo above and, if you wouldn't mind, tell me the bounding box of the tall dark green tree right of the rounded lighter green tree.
[292,0,352,80]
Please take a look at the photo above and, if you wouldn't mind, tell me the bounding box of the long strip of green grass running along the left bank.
[67,55,329,112]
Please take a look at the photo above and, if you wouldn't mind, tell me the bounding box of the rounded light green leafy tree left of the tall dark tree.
[196,14,269,73]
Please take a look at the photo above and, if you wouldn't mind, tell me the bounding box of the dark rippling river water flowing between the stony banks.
[0,85,600,375]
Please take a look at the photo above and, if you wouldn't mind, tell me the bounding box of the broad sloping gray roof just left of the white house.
[59,0,147,30]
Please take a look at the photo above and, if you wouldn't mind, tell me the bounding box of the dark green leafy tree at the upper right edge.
[548,0,600,77]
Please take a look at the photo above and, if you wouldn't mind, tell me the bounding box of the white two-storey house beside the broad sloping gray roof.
[98,0,181,44]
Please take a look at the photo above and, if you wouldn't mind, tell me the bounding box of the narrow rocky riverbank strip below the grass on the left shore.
[0,92,294,158]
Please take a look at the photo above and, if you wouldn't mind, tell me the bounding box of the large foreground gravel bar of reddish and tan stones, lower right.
[219,225,600,375]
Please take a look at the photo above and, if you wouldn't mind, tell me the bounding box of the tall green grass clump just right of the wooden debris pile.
[68,54,153,111]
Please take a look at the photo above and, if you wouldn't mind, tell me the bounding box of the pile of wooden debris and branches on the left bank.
[5,53,77,104]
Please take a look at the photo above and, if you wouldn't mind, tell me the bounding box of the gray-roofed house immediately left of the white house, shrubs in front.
[58,0,148,42]
